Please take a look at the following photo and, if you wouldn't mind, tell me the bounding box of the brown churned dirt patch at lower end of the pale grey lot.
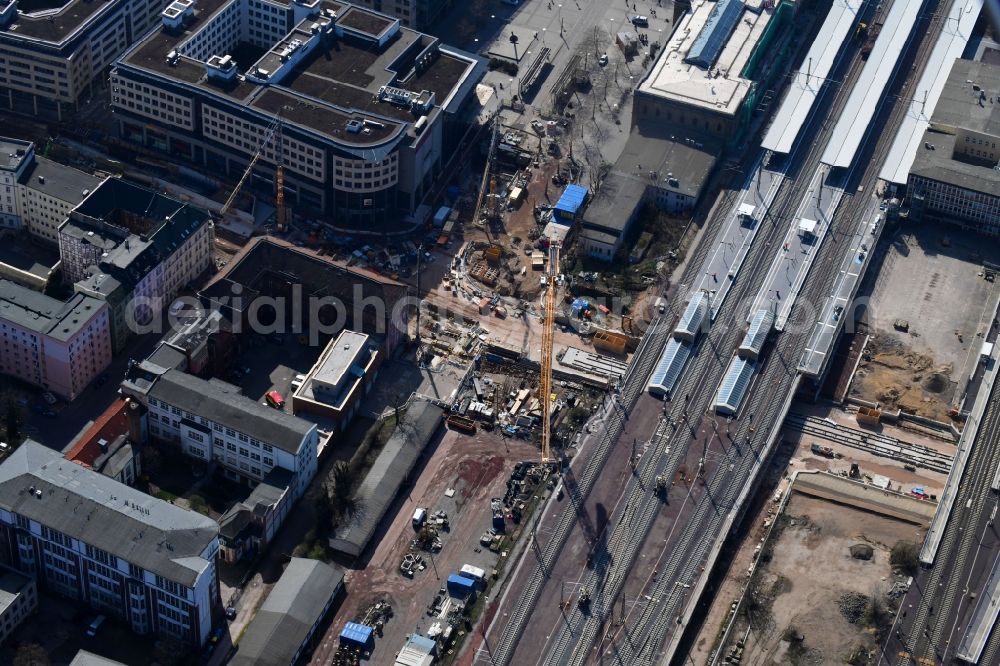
[850,334,960,422]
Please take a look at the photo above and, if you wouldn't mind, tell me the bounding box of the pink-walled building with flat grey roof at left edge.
[0,279,111,400]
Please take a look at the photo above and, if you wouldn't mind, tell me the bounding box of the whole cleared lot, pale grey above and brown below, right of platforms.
[850,224,1000,420]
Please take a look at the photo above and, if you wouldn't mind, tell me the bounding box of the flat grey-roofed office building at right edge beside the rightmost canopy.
[906,60,1000,235]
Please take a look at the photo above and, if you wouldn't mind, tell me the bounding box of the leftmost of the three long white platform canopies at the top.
[762,0,864,154]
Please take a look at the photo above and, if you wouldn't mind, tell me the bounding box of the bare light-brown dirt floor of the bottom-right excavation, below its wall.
[720,493,923,664]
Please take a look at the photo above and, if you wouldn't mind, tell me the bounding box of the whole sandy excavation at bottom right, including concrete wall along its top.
[712,472,933,664]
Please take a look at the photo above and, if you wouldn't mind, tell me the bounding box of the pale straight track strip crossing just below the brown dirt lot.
[785,414,952,474]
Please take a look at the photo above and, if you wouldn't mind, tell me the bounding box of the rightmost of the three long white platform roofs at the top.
[879,0,983,185]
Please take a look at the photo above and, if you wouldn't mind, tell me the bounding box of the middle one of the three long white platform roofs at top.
[820,0,924,168]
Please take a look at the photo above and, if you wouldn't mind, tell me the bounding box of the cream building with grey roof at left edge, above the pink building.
[0,137,101,244]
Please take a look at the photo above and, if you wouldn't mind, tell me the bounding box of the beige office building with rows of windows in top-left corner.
[0,0,166,121]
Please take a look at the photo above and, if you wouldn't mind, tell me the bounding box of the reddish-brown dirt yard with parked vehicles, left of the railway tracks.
[311,431,538,666]
